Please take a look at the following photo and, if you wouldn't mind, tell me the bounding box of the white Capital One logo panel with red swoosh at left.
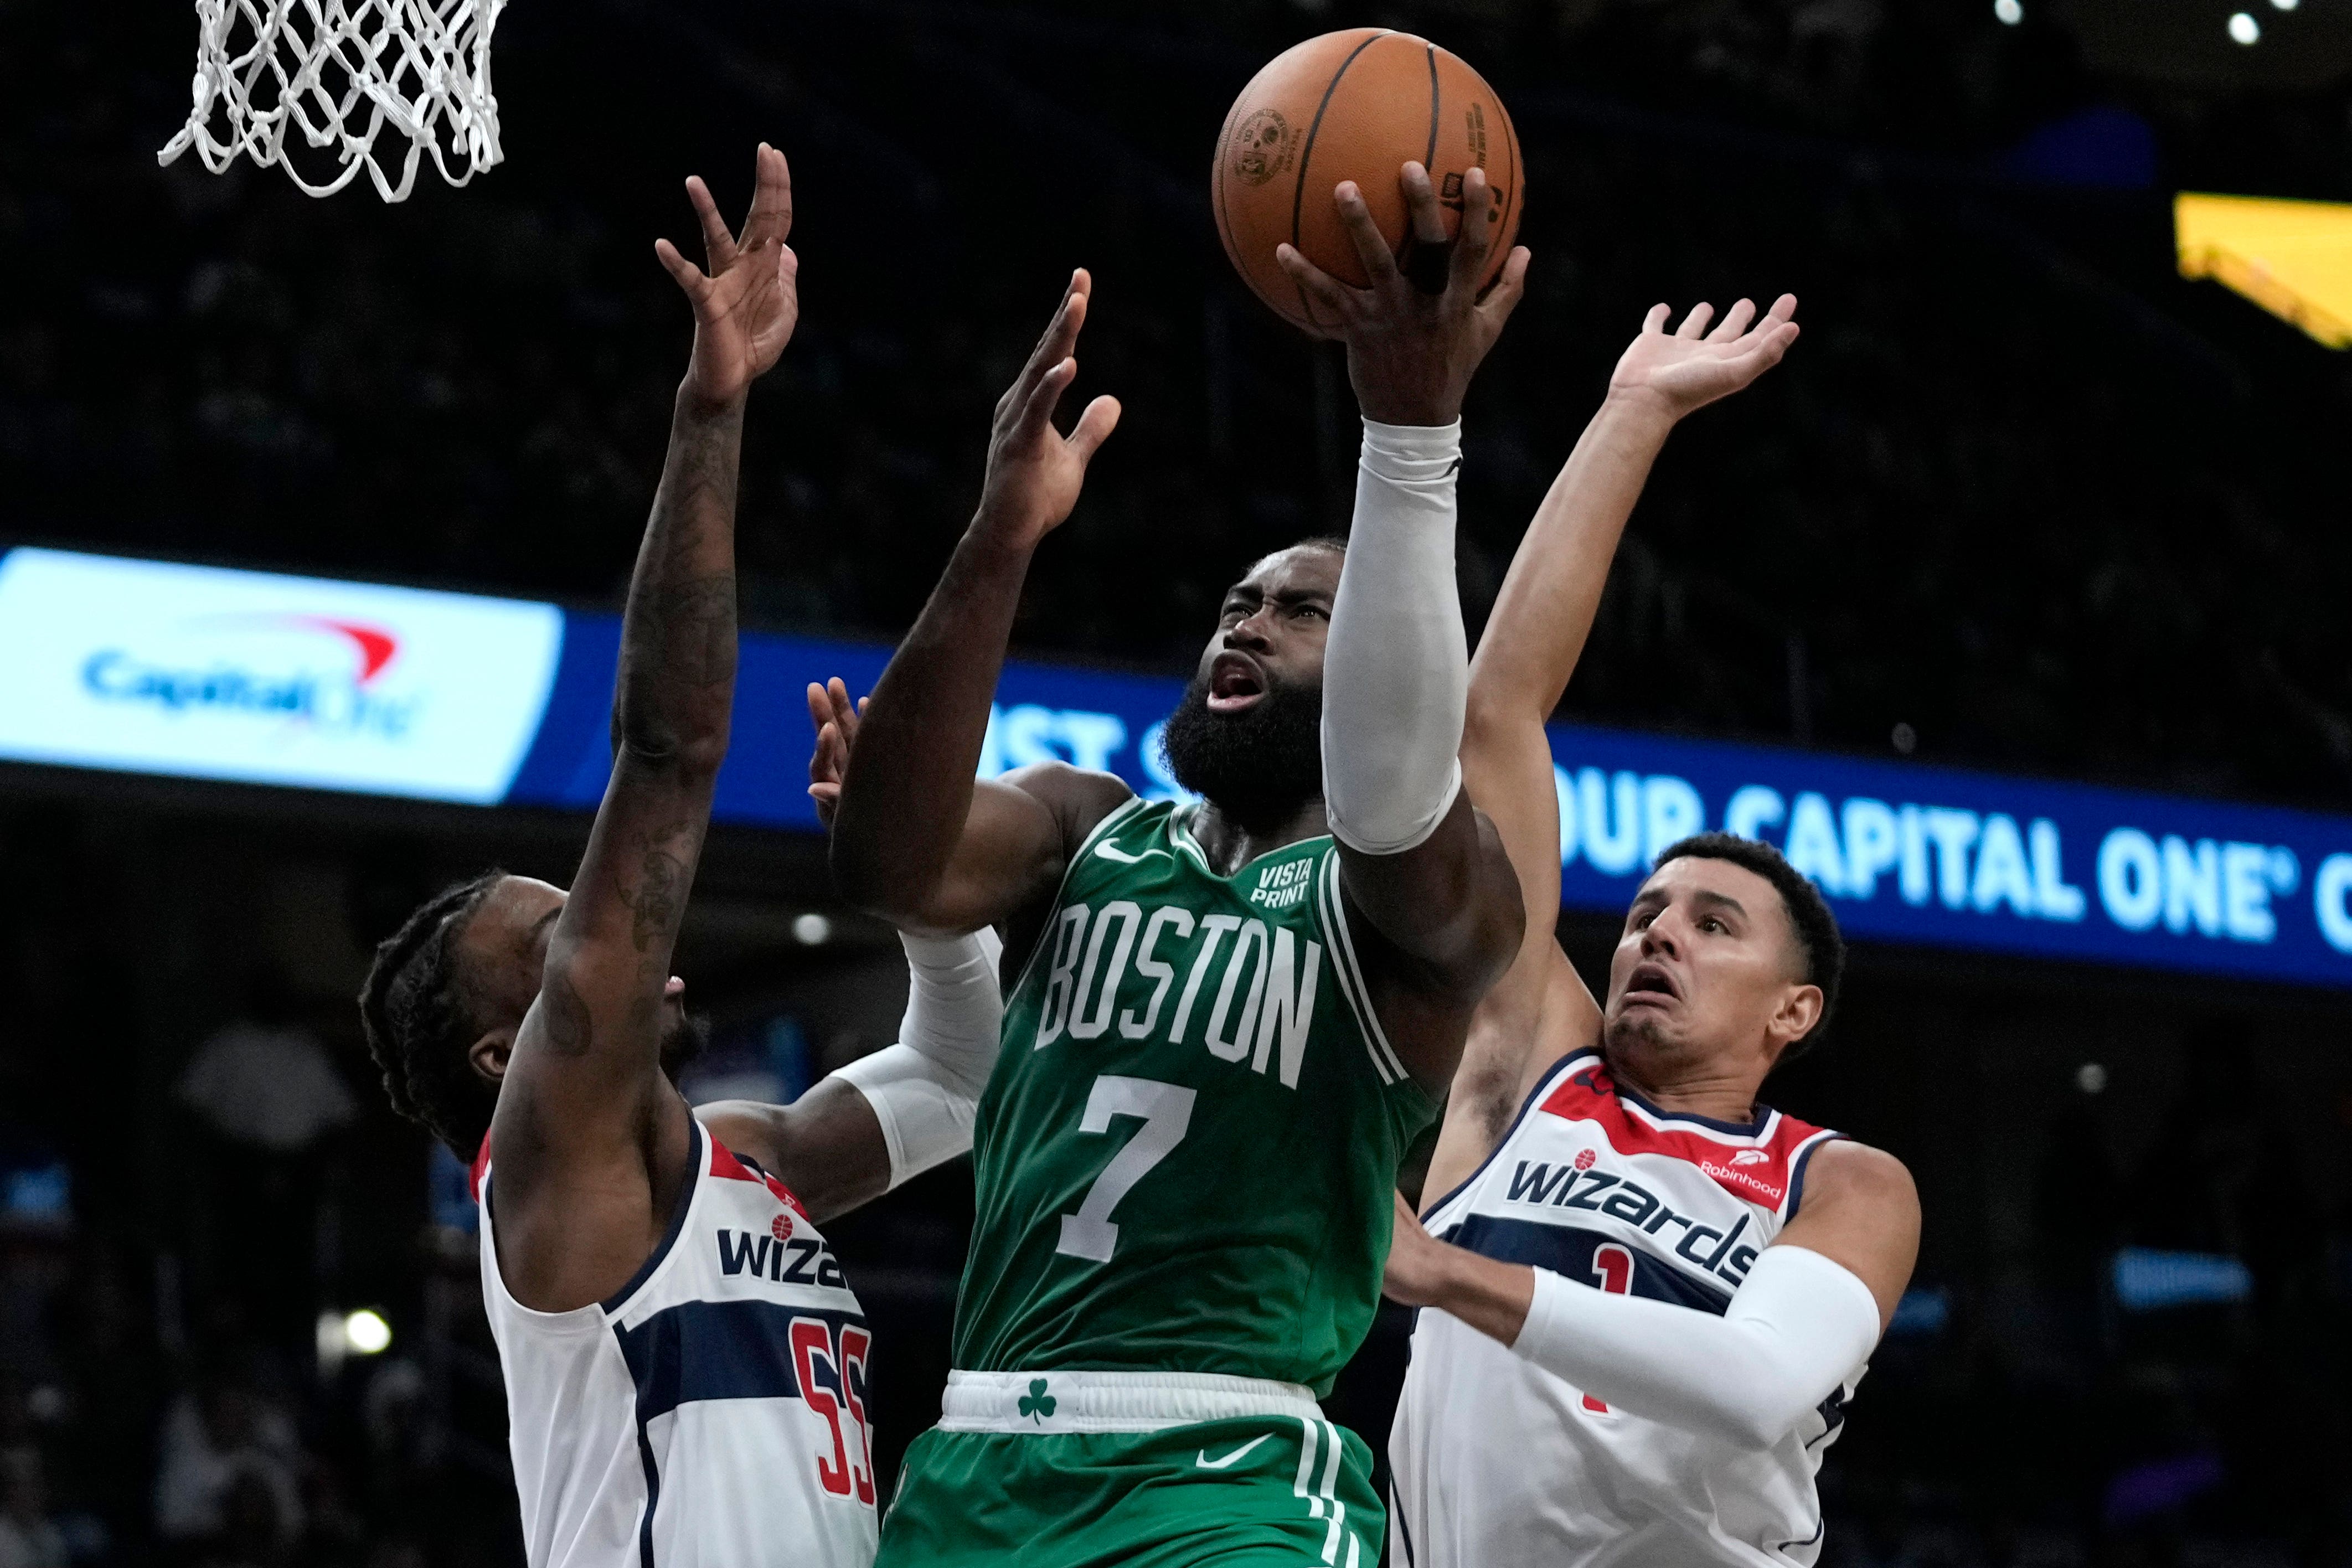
[0,550,562,804]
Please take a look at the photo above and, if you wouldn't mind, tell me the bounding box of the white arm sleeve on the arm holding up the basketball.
[1322,419,1470,855]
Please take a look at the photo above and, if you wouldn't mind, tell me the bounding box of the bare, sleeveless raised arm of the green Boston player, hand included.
[833,270,1127,933]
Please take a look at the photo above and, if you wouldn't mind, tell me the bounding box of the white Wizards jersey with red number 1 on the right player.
[1388,1049,1863,1568]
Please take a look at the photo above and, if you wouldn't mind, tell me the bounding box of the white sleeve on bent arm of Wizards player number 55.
[833,931,1004,1187]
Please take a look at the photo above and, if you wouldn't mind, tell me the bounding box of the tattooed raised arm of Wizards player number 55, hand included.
[489,146,800,1312]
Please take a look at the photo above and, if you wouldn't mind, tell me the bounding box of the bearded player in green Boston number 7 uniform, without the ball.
[833,164,1526,1568]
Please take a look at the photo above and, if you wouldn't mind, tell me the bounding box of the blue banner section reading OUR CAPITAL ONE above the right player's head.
[1552,724,2352,985]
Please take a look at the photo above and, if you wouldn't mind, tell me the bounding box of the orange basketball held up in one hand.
[1209,28,1526,329]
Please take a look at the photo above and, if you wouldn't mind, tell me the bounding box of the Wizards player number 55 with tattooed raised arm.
[360,146,1002,1568]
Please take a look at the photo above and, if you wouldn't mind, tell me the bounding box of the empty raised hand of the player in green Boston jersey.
[981,268,1120,550]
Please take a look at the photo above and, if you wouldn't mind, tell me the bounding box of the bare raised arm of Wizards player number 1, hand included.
[1430,294,1797,1165]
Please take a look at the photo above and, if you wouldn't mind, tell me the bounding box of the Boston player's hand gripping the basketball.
[1275,162,1526,426]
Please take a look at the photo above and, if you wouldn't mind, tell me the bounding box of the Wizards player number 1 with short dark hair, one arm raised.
[1388,296,1919,1568]
